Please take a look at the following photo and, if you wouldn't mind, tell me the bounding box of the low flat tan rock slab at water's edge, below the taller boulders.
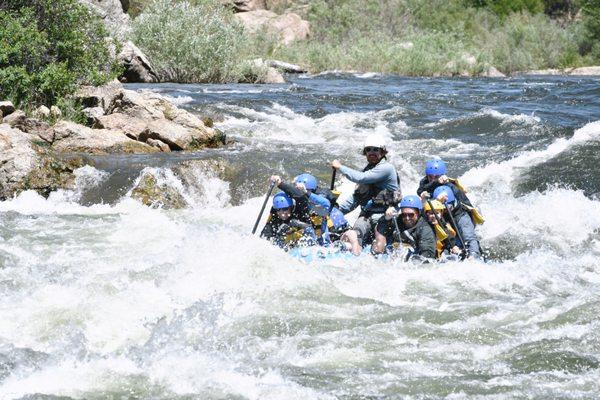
[52,121,159,154]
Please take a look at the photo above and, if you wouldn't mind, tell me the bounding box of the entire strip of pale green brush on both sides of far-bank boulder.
[132,0,600,76]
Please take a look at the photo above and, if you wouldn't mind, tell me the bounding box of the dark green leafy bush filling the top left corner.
[0,0,118,108]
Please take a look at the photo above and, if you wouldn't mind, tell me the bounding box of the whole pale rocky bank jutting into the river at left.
[0,82,225,200]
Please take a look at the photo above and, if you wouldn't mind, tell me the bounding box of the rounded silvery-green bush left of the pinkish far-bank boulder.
[132,0,245,82]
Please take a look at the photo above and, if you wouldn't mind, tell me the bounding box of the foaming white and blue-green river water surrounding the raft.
[0,73,600,400]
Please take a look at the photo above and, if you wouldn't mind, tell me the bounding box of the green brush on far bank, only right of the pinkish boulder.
[270,0,600,75]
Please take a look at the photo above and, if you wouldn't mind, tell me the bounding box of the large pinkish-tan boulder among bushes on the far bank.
[235,10,310,46]
